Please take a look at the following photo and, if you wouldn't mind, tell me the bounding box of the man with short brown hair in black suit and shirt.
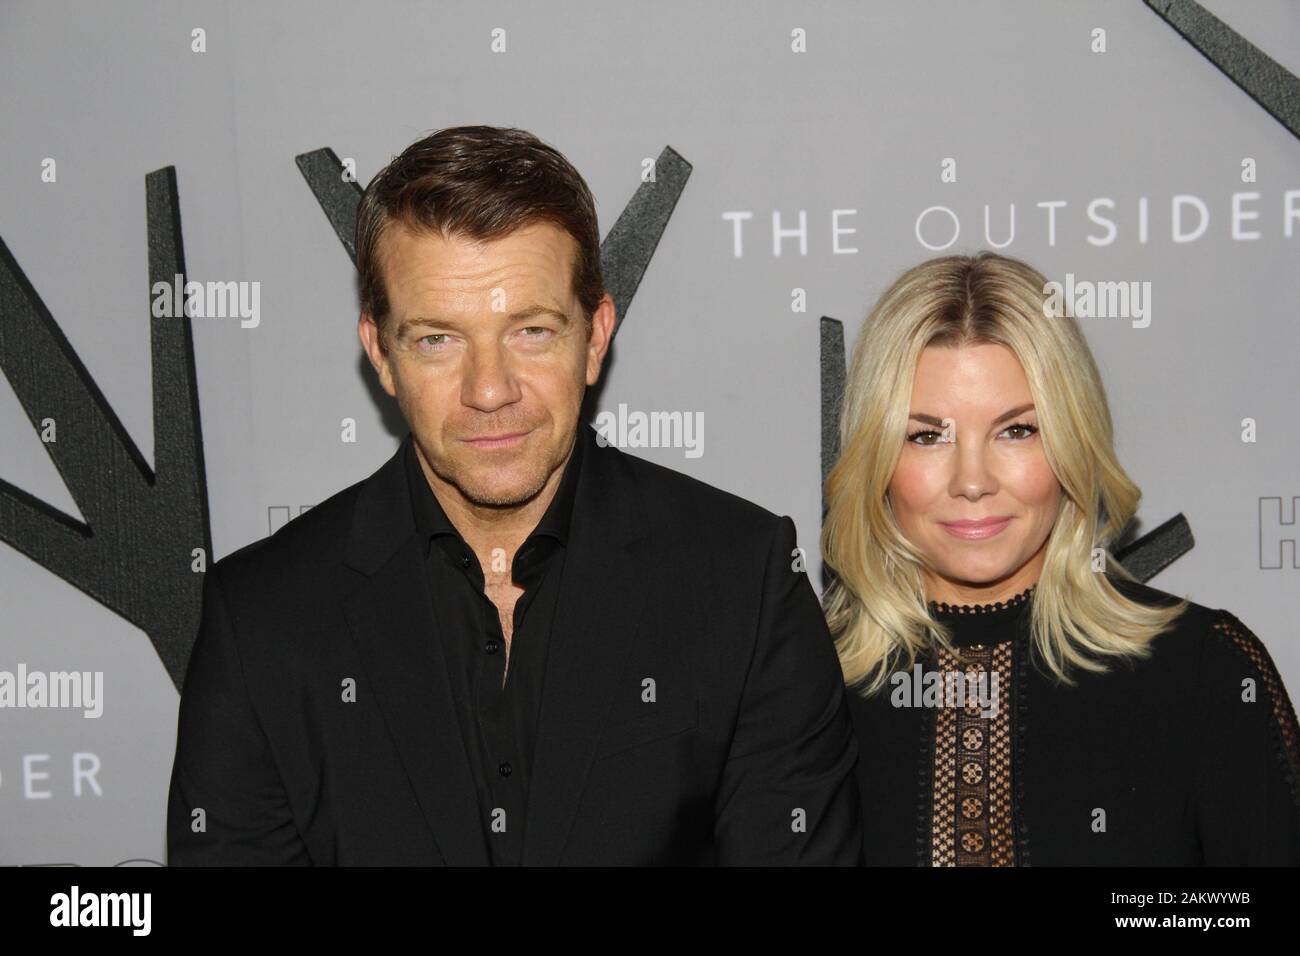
[168,126,862,865]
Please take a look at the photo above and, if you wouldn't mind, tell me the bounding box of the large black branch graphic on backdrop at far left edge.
[0,166,212,687]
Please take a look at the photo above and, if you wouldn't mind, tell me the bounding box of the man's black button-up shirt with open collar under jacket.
[406,423,585,866]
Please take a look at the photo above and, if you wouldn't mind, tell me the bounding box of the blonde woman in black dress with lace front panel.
[822,252,1300,866]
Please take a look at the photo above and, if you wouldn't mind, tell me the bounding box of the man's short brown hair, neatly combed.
[356,126,605,343]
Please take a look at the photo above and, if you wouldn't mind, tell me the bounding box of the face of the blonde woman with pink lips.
[888,345,1061,604]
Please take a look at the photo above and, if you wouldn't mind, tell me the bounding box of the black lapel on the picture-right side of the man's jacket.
[523,424,649,866]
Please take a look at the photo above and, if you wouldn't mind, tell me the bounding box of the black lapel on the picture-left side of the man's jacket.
[343,436,490,866]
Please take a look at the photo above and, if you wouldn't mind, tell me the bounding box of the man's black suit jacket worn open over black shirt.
[168,425,862,865]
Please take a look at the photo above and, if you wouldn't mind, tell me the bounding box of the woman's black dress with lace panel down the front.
[848,580,1300,866]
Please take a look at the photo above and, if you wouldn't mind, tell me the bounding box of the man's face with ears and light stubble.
[359,222,614,507]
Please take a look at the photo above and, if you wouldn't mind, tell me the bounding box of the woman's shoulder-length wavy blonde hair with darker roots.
[822,251,1187,695]
